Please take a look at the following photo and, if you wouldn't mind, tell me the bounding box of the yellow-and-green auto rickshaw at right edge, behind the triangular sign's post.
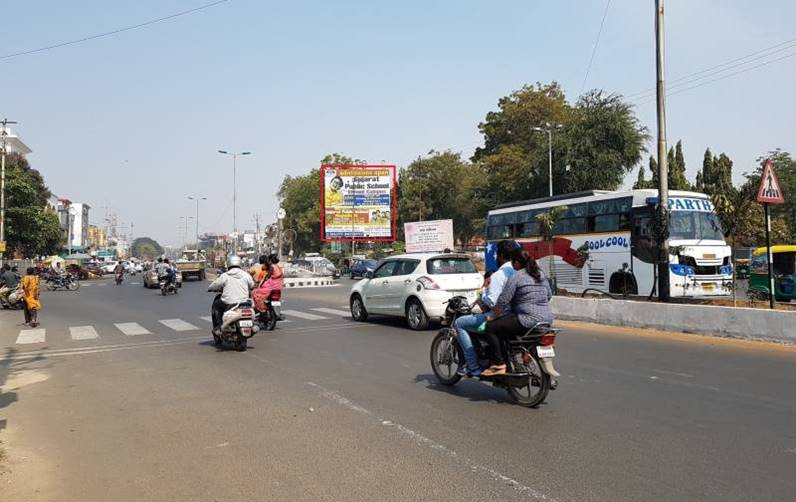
[748,246,796,302]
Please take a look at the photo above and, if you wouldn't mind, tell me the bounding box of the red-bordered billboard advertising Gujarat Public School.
[321,165,396,242]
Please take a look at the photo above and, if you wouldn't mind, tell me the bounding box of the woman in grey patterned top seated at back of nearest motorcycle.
[481,251,553,376]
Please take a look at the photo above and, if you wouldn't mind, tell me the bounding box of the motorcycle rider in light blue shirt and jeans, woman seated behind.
[453,240,521,377]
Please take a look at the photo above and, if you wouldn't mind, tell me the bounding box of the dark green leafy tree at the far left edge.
[6,153,63,256]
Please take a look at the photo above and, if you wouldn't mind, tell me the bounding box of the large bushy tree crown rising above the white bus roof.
[472,82,647,203]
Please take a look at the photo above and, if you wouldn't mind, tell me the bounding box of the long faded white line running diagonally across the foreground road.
[306,382,556,502]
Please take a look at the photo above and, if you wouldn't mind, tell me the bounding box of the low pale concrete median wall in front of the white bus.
[551,296,796,343]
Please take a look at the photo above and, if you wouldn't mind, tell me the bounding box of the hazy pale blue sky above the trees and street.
[0,0,796,245]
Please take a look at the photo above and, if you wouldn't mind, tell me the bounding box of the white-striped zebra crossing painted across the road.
[7,307,351,345]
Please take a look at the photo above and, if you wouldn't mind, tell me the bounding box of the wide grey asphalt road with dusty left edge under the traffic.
[0,278,796,502]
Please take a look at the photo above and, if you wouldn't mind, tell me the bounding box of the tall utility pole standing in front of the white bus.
[655,0,669,302]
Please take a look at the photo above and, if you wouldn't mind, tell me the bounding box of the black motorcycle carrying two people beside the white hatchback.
[431,296,561,408]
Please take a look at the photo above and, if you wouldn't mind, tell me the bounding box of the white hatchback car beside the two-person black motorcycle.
[349,253,484,330]
